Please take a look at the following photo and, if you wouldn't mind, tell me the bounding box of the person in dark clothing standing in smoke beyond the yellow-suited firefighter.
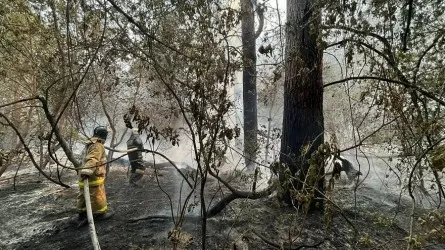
[127,128,145,186]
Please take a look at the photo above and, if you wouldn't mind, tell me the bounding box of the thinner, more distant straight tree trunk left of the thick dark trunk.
[241,0,258,169]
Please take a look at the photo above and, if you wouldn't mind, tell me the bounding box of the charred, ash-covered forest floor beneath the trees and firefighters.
[0,161,445,249]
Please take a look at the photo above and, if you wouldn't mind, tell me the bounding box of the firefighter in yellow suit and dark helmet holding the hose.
[77,127,113,226]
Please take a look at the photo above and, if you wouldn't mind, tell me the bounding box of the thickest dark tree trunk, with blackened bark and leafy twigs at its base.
[280,0,324,209]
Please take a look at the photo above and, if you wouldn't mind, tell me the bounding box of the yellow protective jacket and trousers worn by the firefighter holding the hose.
[77,137,107,214]
